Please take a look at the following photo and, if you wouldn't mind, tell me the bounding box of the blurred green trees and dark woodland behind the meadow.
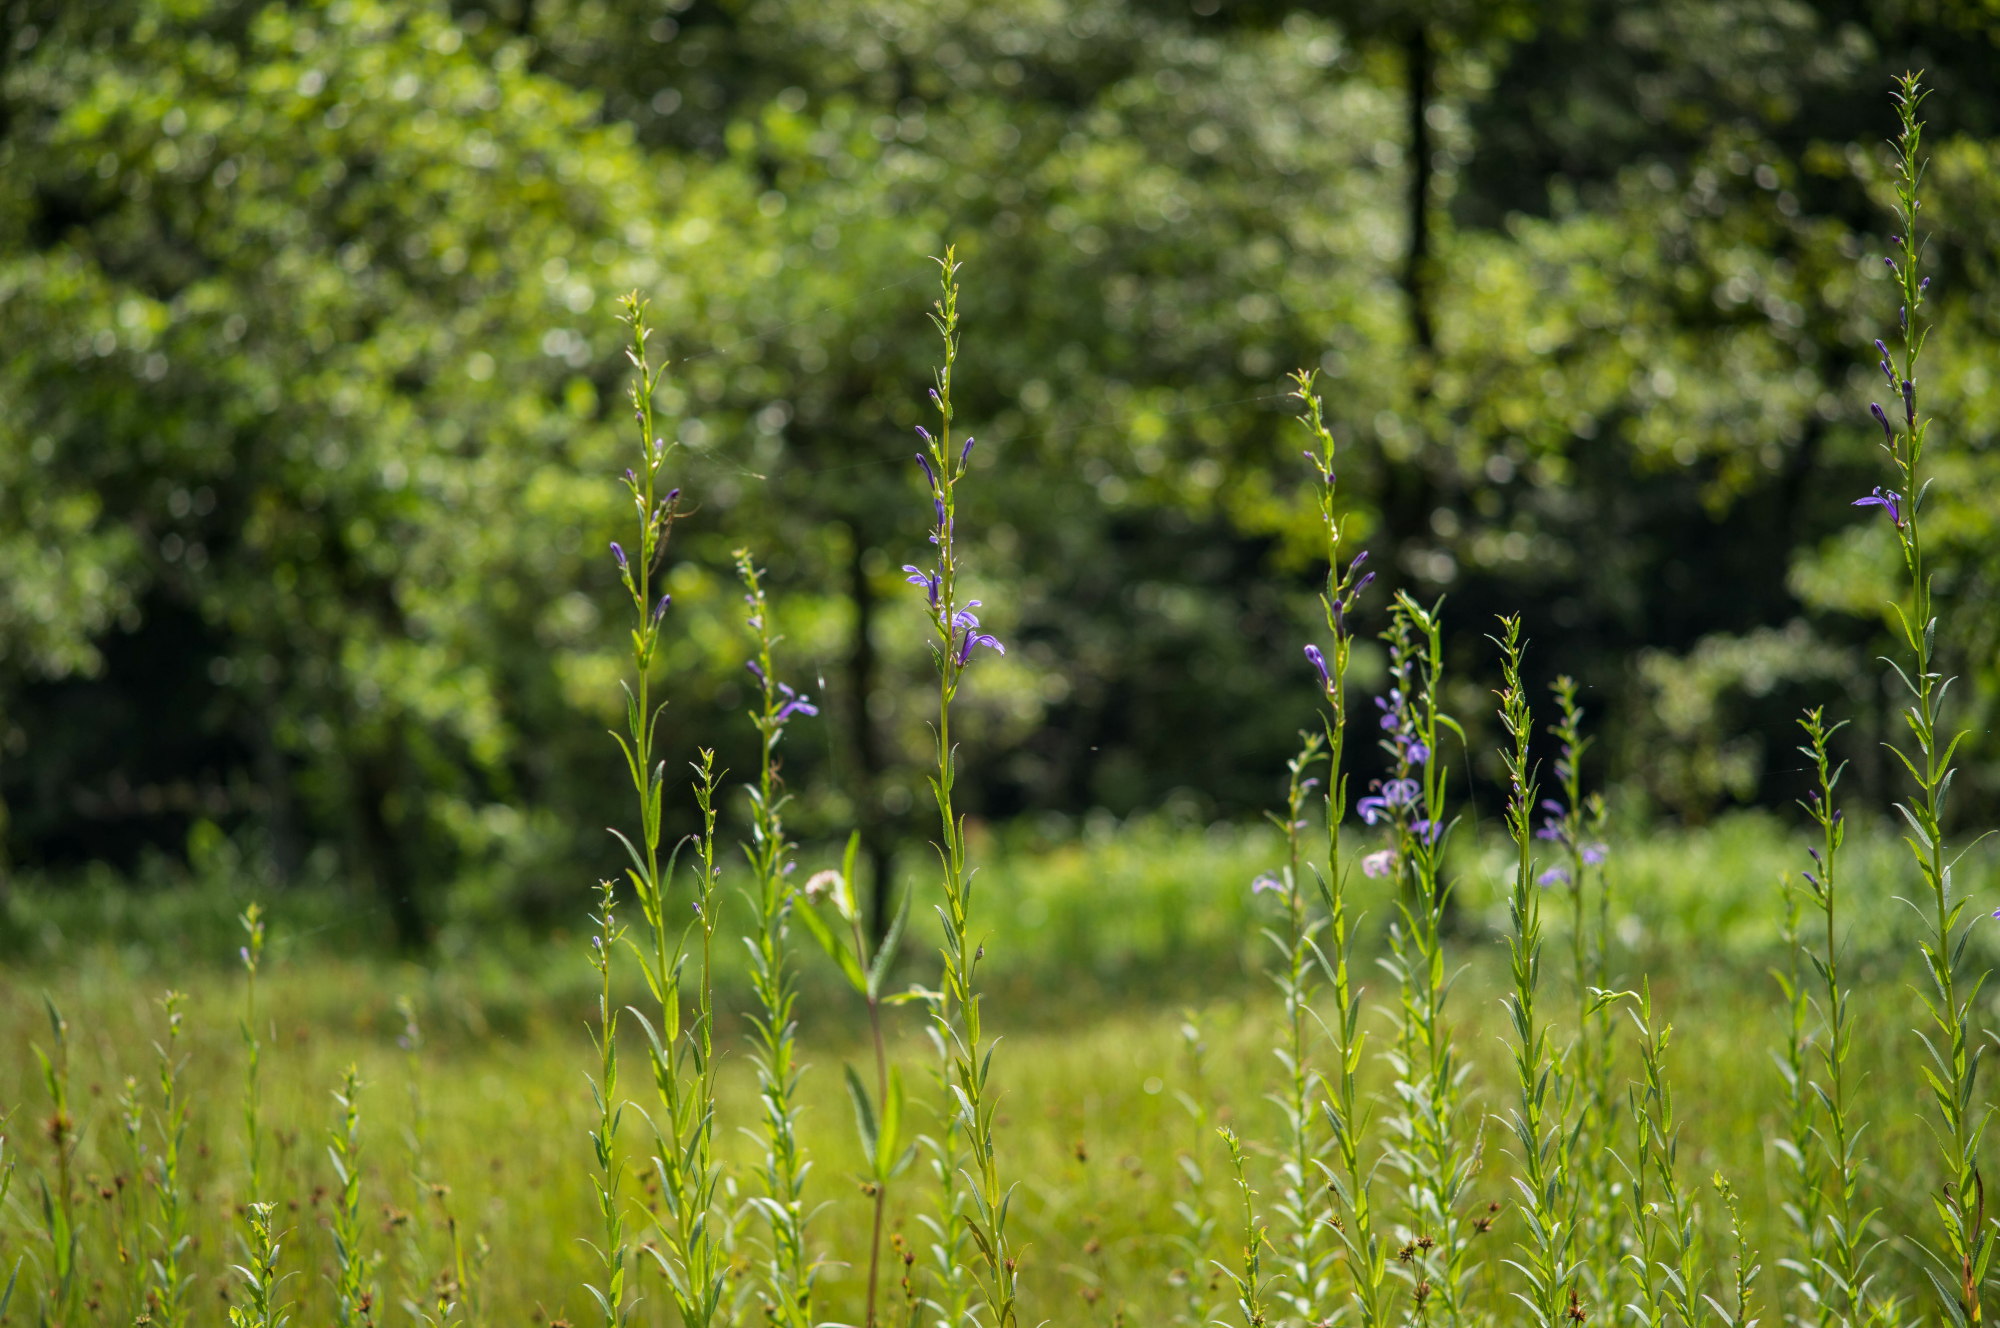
[0,0,2000,946]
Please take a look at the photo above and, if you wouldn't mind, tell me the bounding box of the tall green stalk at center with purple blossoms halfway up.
[906,248,1020,1328]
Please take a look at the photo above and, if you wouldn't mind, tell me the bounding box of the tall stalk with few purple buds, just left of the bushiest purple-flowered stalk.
[1294,372,1384,1328]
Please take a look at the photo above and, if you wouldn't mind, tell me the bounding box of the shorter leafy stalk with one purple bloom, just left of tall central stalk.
[736,550,820,1328]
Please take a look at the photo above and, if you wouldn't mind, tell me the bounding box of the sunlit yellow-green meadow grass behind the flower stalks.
[0,818,2000,1324]
